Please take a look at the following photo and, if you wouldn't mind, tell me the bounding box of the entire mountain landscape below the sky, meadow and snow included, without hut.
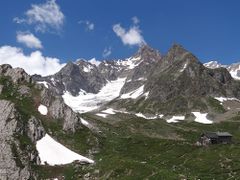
[0,44,240,180]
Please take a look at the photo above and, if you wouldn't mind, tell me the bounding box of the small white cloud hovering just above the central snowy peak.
[113,24,145,46]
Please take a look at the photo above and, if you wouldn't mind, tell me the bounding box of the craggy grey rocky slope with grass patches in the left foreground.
[0,65,93,180]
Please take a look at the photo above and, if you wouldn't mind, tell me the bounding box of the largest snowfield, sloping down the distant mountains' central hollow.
[62,78,126,113]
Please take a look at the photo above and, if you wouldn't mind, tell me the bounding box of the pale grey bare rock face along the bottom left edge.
[0,100,31,180]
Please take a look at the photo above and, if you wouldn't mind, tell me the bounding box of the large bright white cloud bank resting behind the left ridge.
[0,46,65,76]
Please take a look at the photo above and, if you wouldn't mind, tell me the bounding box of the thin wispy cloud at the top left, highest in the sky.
[13,0,65,32]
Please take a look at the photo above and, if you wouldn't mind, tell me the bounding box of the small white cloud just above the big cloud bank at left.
[17,32,43,49]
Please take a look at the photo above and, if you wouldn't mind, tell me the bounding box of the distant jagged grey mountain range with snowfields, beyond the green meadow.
[33,44,240,114]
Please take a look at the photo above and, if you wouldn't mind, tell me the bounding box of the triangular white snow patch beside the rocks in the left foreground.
[36,134,94,166]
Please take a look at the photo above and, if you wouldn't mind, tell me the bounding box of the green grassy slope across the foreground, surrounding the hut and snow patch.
[1,76,240,179]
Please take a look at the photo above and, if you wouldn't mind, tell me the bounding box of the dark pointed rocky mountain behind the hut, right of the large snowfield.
[116,45,240,113]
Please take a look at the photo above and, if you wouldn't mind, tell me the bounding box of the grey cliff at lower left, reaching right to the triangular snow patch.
[0,100,45,180]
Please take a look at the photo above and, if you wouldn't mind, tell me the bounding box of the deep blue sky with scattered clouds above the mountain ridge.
[0,0,240,73]
